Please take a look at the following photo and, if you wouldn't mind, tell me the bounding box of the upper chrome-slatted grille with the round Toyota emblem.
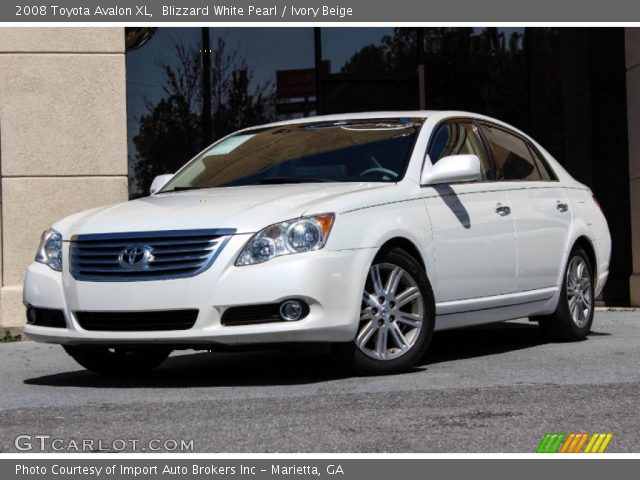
[69,229,235,282]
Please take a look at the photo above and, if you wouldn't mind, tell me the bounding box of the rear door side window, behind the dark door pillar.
[480,124,549,181]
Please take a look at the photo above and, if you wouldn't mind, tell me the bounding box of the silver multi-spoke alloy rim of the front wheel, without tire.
[355,263,424,360]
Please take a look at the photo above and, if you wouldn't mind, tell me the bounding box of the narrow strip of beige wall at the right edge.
[625,28,640,307]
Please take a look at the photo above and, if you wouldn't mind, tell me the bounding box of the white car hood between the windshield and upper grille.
[53,183,396,240]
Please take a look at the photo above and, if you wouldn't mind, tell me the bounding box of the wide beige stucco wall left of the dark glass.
[0,28,127,327]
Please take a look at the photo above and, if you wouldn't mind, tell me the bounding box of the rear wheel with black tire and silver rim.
[537,247,594,342]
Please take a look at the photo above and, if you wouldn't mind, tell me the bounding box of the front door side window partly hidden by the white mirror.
[428,121,495,180]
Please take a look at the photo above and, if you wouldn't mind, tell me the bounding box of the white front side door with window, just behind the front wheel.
[424,119,516,303]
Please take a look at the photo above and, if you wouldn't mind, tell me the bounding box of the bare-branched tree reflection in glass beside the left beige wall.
[129,38,275,198]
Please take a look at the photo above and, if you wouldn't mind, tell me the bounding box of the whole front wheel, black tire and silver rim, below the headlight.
[339,248,435,375]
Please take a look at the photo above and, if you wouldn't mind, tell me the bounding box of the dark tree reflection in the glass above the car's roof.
[341,28,528,127]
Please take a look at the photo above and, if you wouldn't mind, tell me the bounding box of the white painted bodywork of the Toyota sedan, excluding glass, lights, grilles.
[24,111,611,345]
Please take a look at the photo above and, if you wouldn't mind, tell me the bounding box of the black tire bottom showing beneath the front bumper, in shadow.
[64,345,171,376]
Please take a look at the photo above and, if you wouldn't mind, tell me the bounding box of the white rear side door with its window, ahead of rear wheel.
[479,123,572,292]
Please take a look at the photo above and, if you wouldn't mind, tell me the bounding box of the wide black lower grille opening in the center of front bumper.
[75,310,198,332]
